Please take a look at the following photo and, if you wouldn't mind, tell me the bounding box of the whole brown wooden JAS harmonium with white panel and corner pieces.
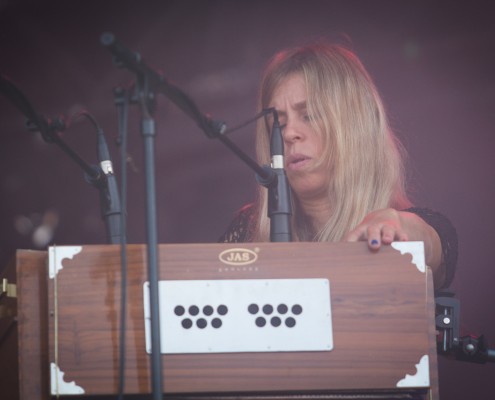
[48,242,437,399]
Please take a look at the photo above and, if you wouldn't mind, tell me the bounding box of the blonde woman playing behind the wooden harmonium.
[222,44,457,288]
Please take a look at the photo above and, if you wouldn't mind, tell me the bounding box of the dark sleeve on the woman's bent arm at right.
[404,207,458,288]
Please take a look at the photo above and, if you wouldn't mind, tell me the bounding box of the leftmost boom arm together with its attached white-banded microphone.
[0,75,120,243]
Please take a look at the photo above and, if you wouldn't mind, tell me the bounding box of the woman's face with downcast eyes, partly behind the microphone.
[270,74,329,201]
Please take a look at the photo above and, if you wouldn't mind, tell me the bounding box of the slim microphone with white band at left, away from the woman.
[97,128,122,244]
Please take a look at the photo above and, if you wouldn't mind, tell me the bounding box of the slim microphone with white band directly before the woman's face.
[268,108,292,242]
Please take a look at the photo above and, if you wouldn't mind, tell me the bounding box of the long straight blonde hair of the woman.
[253,43,411,241]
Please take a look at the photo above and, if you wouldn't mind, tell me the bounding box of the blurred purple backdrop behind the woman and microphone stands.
[0,0,495,400]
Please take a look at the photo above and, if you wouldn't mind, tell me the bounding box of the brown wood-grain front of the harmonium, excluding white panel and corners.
[47,243,436,394]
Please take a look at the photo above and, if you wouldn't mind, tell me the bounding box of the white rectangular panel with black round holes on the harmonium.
[144,279,333,353]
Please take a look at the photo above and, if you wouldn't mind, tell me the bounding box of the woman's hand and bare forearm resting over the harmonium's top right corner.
[343,208,445,286]
